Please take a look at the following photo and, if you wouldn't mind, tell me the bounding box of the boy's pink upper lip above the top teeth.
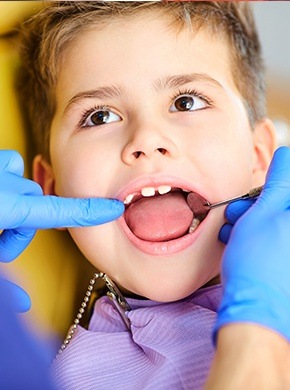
[116,174,206,202]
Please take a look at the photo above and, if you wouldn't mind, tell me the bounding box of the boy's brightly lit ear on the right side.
[253,118,277,186]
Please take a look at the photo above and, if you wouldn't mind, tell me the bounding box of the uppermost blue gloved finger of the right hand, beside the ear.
[257,146,290,213]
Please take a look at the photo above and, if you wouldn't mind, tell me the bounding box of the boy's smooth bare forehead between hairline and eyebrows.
[58,11,235,103]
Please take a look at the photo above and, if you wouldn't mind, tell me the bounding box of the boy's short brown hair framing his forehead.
[19,1,265,158]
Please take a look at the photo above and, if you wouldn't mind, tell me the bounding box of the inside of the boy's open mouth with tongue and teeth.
[124,185,209,243]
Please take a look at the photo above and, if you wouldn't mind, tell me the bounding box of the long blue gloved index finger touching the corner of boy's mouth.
[0,194,125,229]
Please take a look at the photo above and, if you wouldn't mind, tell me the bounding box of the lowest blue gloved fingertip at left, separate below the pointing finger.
[0,278,31,313]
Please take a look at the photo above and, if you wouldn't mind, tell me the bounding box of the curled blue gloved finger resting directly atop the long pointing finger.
[0,172,43,195]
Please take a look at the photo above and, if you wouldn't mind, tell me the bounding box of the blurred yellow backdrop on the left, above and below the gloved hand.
[0,1,93,346]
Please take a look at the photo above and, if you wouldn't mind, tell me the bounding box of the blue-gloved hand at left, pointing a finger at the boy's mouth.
[0,150,124,311]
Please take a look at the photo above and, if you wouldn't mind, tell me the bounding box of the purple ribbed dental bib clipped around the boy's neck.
[52,285,222,390]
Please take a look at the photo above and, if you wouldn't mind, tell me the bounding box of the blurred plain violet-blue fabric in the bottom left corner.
[0,276,53,390]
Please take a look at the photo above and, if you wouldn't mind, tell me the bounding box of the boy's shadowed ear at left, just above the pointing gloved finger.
[32,154,55,195]
